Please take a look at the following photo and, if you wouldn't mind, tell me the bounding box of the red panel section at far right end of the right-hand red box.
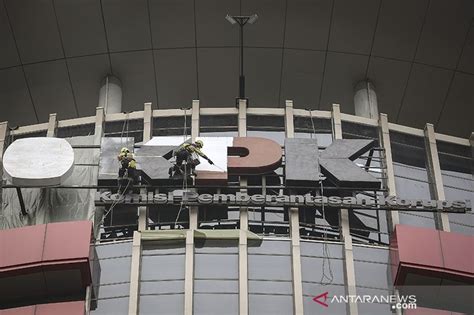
[439,231,474,275]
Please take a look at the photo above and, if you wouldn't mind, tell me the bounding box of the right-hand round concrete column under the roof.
[354,80,379,119]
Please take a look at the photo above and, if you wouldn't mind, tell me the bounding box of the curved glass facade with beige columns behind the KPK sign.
[0,100,474,315]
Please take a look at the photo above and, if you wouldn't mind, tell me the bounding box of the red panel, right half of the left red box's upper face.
[43,221,92,261]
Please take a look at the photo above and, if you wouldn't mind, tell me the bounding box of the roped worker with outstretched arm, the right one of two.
[168,140,214,177]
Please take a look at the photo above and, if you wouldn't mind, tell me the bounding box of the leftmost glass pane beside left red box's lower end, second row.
[99,257,132,285]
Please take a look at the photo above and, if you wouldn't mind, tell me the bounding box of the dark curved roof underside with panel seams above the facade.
[0,0,474,137]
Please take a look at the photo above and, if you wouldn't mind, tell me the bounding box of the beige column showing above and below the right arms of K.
[332,104,359,315]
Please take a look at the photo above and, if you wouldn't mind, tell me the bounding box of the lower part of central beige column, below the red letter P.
[239,176,249,315]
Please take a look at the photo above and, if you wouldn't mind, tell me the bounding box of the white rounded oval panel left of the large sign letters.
[3,137,74,187]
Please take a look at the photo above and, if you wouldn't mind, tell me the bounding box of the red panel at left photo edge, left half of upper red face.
[0,225,46,271]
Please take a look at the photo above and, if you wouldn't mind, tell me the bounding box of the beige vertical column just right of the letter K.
[379,114,400,233]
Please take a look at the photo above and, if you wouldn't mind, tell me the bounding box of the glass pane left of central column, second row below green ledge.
[194,253,239,279]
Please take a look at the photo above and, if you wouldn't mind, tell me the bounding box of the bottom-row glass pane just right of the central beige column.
[249,294,293,315]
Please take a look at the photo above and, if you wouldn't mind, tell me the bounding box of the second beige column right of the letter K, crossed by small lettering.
[424,124,450,232]
